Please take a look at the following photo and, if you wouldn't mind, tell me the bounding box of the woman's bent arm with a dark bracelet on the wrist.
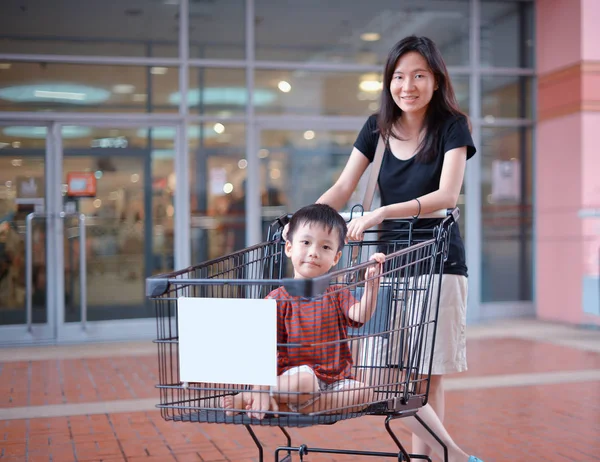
[348,146,467,240]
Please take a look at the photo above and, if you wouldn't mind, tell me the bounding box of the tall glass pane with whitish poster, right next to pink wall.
[481,127,533,302]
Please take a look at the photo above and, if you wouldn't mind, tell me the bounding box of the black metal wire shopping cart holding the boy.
[147,209,459,461]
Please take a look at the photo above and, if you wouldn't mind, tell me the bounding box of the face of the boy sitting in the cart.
[285,223,342,279]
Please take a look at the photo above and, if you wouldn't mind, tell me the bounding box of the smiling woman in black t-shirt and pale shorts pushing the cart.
[317,36,475,454]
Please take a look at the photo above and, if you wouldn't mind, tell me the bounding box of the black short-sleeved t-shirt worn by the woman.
[354,115,476,276]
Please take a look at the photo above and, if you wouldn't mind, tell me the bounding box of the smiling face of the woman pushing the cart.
[390,51,437,116]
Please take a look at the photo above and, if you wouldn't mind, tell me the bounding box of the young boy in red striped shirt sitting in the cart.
[221,204,385,419]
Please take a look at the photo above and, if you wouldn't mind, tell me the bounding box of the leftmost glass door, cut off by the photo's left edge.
[0,123,55,344]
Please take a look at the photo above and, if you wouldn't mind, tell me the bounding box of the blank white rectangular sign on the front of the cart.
[177,297,277,385]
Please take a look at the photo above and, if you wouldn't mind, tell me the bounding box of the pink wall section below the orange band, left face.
[536,114,582,323]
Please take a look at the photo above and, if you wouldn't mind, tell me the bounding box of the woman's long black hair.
[377,35,466,162]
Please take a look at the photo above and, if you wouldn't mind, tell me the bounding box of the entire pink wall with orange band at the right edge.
[535,0,600,325]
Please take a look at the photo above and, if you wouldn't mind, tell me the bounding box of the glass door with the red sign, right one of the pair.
[58,126,176,341]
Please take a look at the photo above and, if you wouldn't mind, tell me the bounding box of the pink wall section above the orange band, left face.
[535,0,580,75]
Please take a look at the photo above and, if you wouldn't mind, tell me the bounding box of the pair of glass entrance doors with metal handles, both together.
[0,121,177,345]
